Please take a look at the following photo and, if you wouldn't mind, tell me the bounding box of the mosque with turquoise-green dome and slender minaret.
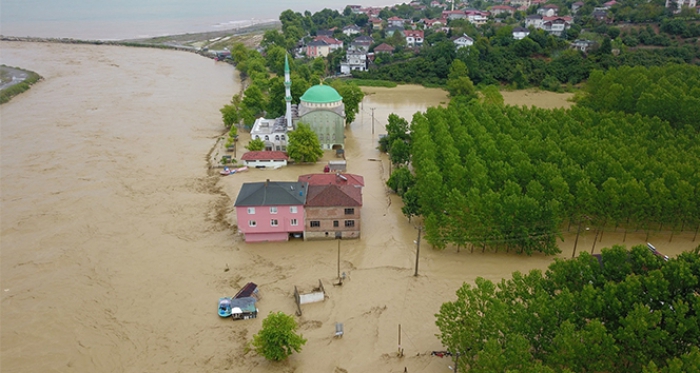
[250,56,345,151]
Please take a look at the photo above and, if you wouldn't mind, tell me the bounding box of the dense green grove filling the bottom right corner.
[436,246,700,373]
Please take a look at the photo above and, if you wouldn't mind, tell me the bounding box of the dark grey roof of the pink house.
[233,180,309,206]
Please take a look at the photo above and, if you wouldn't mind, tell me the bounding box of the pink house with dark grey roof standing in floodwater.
[234,180,309,242]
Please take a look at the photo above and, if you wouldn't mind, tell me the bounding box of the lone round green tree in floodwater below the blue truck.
[252,312,306,361]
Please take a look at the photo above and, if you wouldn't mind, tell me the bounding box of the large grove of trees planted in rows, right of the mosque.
[383,66,700,254]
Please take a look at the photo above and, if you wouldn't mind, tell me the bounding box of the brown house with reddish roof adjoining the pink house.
[299,174,364,240]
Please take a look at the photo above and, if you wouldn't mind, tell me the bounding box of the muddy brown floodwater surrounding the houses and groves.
[0,43,695,372]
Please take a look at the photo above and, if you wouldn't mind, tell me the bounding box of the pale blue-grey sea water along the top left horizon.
[0,0,400,40]
